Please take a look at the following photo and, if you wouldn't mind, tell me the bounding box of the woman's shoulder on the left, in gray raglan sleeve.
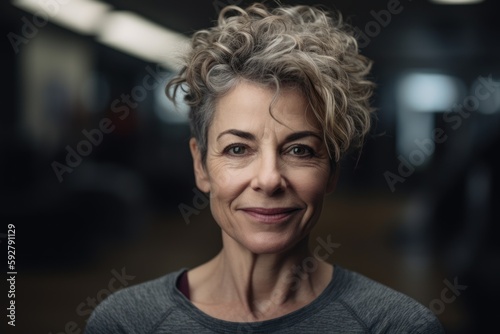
[85,270,184,334]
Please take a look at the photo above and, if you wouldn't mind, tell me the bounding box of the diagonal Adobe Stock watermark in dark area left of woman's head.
[51,65,168,183]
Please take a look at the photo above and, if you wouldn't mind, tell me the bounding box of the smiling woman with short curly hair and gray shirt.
[86,4,442,333]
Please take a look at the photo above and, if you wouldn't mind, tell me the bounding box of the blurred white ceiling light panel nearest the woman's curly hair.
[98,11,190,71]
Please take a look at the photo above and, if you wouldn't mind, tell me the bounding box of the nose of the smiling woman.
[251,152,286,196]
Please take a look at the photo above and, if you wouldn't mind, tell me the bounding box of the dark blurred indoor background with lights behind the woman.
[0,0,500,334]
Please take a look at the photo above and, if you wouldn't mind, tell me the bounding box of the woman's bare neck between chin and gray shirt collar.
[190,232,333,321]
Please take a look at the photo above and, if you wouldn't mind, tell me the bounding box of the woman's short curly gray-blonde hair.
[166,3,374,162]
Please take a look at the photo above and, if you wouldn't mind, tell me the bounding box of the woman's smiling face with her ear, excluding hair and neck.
[190,82,334,254]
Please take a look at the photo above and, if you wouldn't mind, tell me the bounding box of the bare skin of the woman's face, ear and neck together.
[188,81,335,322]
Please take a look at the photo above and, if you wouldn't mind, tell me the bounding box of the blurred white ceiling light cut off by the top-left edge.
[12,0,112,35]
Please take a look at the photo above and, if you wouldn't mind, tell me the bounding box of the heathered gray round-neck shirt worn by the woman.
[85,265,444,334]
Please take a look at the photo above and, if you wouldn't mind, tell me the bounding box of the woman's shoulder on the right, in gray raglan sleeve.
[339,269,444,333]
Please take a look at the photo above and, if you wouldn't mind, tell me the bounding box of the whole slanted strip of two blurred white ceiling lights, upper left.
[12,0,190,71]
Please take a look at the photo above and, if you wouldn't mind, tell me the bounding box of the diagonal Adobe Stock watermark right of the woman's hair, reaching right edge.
[383,75,500,192]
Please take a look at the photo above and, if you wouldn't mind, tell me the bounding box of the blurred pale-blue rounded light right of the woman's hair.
[399,73,460,112]
